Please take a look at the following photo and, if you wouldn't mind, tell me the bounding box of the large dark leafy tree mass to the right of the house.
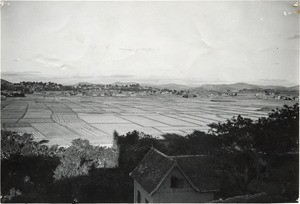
[209,104,299,201]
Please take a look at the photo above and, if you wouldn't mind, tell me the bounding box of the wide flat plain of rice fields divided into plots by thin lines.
[1,95,295,146]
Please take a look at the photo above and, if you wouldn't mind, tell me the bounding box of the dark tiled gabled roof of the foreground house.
[129,148,219,194]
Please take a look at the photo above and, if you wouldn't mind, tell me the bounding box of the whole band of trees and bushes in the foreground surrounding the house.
[1,104,299,202]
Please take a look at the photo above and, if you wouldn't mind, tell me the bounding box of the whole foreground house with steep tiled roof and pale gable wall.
[129,148,219,203]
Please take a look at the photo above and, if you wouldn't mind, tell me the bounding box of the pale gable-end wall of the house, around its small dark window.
[152,167,214,203]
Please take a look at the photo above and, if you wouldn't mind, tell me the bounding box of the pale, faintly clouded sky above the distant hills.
[1,1,299,86]
